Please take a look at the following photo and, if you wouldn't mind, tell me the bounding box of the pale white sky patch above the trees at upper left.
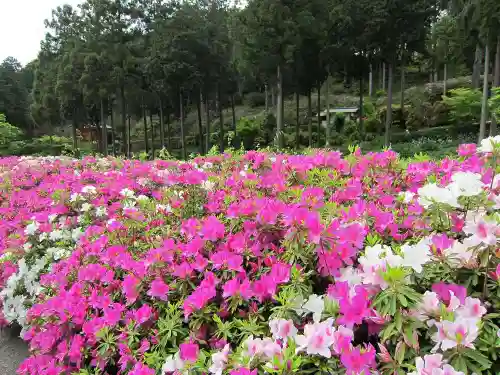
[0,0,81,65]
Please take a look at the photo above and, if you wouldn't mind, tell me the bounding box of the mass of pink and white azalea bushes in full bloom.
[0,137,500,375]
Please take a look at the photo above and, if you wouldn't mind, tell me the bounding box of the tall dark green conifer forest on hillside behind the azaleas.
[0,0,500,158]
